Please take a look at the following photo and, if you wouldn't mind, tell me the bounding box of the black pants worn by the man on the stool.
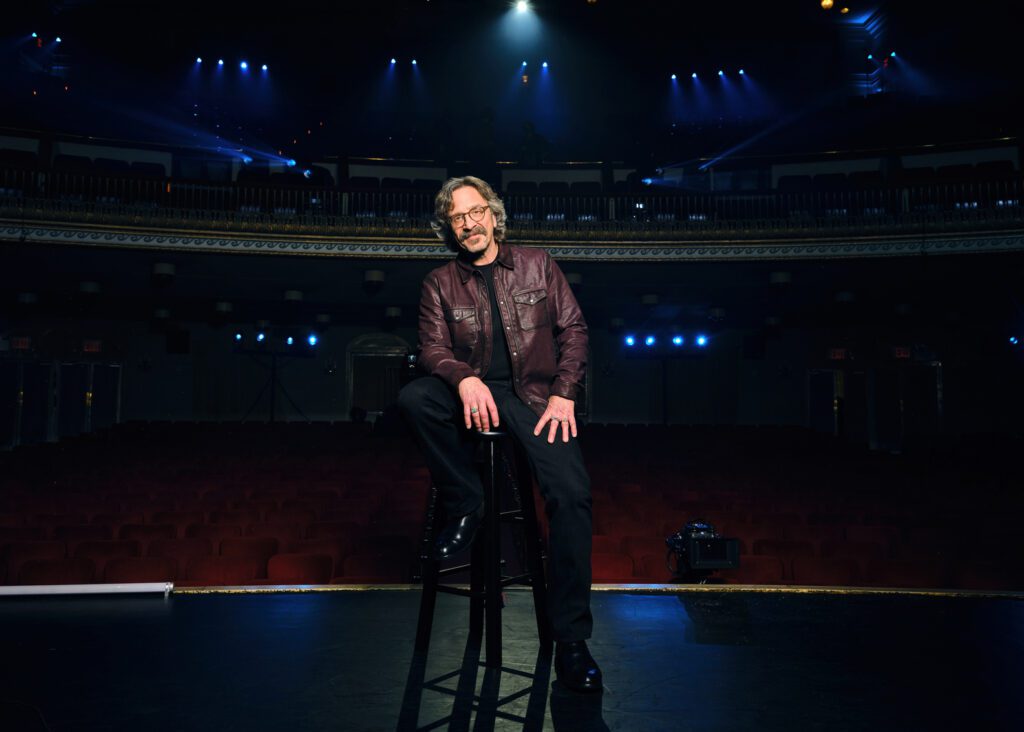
[398,377,593,641]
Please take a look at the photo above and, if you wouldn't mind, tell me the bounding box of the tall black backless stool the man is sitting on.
[416,430,552,669]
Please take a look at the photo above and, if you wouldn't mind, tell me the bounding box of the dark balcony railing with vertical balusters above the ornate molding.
[0,169,1024,241]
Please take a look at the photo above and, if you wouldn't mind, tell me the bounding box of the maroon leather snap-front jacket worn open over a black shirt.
[419,244,587,415]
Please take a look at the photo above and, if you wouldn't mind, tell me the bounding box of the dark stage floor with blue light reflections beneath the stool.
[0,588,1024,732]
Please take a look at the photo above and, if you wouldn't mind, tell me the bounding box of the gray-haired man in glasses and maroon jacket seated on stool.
[398,176,601,691]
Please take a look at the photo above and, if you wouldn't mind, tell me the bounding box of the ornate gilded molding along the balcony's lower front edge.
[0,220,1024,262]
